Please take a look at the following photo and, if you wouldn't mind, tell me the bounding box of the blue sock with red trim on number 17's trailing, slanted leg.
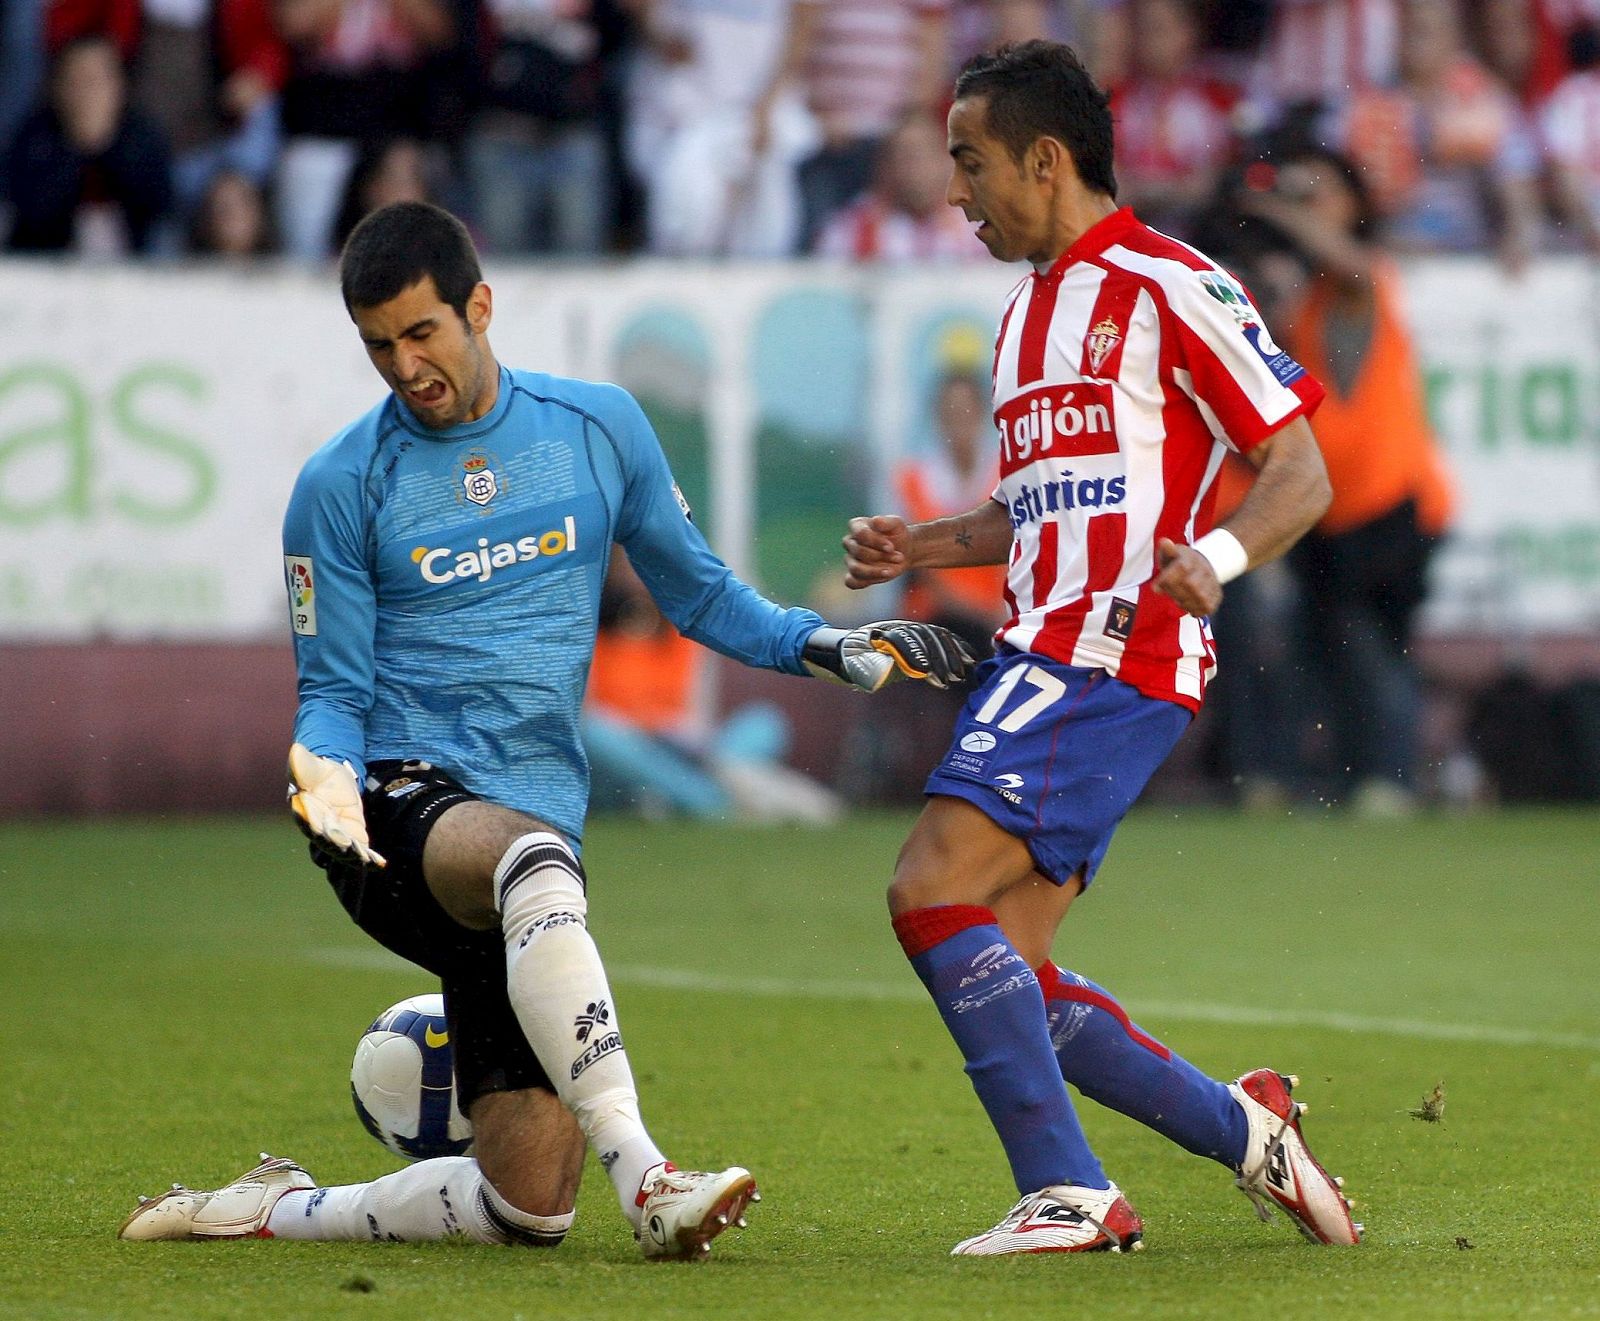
[1038,963,1250,1169]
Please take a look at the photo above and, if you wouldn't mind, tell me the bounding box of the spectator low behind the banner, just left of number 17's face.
[816,110,984,262]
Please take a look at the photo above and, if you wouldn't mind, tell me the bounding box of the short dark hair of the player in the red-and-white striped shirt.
[955,42,1117,197]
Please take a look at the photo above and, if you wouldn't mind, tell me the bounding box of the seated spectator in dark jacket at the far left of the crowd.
[0,37,173,257]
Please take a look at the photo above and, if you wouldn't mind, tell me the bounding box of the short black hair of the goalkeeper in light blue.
[339,202,483,320]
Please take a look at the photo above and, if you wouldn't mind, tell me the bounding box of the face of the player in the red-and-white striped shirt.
[944,96,1053,262]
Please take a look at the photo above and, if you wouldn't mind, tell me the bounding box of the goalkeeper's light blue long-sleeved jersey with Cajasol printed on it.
[283,368,822,840]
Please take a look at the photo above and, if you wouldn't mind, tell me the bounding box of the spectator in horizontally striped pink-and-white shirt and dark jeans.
[789,0,949,248]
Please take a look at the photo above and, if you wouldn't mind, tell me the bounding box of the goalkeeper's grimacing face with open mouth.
[350,275,499,430]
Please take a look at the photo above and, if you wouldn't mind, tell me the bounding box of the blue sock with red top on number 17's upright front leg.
[894,905,1110,1193]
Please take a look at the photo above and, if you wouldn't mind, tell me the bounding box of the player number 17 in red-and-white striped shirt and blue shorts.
[845,42,1360,1255]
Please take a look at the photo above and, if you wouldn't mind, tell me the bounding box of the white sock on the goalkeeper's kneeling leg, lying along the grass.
[267,1156,573,1247]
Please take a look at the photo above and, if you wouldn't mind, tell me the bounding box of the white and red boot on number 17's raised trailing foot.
[1227,1068,1362,1246]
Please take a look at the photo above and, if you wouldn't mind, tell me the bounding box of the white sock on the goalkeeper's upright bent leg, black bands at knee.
[494,832,666,1230]
